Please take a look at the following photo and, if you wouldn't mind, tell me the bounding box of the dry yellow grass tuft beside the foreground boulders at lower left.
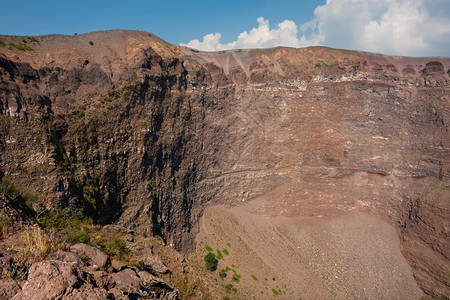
[21,225,63,261]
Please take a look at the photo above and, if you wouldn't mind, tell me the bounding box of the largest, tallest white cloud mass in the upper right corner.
[310,0,450,56]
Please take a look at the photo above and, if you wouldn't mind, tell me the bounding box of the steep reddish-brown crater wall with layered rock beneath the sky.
[0,31,450,295]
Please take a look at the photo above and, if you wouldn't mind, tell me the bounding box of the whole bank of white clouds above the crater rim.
[181,0,450,56]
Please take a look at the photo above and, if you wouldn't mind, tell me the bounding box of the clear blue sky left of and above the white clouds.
[0,0,325,44]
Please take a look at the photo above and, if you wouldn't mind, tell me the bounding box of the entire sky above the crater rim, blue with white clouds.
[0,0,450,56]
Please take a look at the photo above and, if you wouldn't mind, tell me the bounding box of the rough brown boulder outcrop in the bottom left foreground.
[9,244,179,300]
